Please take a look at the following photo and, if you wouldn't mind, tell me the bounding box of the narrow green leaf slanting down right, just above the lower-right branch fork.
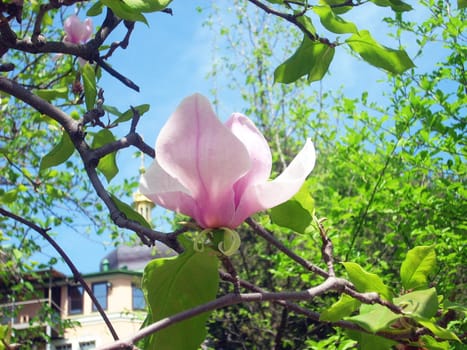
[342,262,392,301]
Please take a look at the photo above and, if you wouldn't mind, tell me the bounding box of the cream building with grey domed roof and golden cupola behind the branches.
[0,193,174,350]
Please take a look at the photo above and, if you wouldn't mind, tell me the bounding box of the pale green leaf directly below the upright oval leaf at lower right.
[393,288,438,318]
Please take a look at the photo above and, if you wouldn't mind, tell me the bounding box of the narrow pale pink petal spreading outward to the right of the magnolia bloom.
[231,139,316,227]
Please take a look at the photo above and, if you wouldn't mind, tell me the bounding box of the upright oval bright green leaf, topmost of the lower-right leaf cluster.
[400,245,436,290]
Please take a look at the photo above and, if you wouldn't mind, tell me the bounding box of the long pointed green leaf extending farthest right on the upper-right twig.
[346,30,415,74]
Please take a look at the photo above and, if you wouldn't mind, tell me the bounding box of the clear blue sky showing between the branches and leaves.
[35,0,441,273]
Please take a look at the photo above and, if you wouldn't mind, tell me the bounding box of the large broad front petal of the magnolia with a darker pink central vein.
[156,94,250,227]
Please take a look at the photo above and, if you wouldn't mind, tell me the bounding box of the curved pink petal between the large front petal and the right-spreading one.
[225,113,272,205]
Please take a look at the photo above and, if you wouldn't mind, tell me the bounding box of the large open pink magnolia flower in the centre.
[140,94,315,228]
